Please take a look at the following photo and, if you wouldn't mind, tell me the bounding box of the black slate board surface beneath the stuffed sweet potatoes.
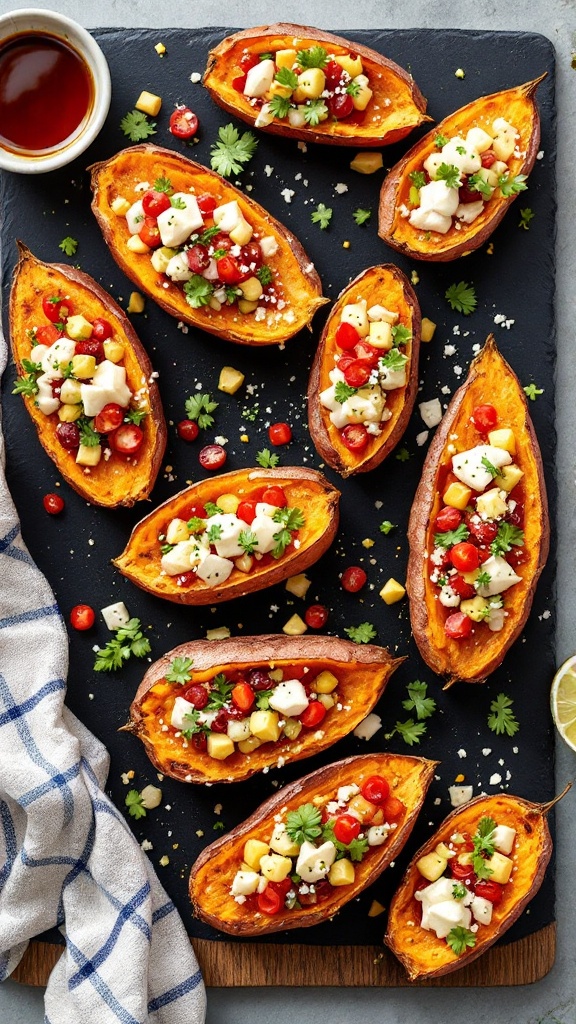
[1,29,556,944]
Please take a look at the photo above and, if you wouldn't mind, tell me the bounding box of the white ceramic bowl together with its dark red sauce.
[0,8,111,174]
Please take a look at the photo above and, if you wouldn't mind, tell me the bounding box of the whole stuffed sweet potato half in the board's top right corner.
[378,76,544,262]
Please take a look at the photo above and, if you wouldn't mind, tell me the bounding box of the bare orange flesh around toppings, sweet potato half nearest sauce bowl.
[91,144,328,345]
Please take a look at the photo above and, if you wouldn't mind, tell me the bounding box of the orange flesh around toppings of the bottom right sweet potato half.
[384,794,552,981]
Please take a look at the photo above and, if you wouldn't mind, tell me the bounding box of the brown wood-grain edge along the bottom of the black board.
[12,924,557,988]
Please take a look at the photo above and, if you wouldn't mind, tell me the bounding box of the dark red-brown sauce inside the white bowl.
[0,32,93,153]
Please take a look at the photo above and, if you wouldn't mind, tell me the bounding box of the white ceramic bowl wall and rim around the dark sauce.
[0,7,112,174]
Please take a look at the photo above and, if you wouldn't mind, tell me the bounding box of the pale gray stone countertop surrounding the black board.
[0,0,576,1024]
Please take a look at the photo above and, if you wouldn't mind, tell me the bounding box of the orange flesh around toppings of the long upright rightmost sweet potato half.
[407,335,549,683]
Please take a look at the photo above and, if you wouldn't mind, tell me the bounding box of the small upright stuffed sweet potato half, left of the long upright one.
[308,263,421,476]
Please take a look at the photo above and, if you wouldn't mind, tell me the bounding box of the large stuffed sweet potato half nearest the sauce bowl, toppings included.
[91,144,328,345]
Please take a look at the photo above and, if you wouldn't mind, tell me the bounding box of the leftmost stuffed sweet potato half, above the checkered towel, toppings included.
[9,242,166,508]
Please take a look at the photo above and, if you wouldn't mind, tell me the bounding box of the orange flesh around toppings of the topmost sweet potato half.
[203,24,430,147]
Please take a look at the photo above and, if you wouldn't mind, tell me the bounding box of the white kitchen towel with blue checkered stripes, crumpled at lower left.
[0,335,205,1024]
